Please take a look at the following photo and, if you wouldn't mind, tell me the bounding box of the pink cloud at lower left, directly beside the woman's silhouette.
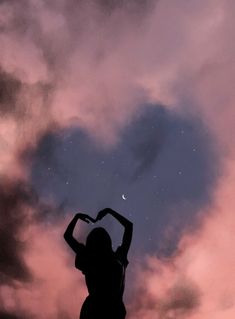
[0,215,87,319]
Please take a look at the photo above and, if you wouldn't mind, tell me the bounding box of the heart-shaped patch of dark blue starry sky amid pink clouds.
[31,105,217,254]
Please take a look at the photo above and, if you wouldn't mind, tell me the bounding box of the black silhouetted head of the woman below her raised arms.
[86,227,112,253]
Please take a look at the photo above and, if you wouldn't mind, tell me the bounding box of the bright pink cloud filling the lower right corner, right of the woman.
[130,163,235,319]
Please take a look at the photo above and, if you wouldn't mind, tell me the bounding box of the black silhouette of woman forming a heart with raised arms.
[64,208,133,319]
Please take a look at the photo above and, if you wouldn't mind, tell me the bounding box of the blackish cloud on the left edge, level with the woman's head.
[0,179,35,284]
